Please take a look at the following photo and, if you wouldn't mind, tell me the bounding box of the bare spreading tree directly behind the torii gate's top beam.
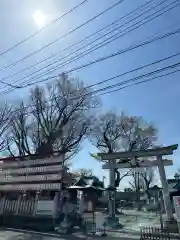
[90,112,156,188]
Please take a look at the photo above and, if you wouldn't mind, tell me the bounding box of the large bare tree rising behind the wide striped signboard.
[5,74,99,159]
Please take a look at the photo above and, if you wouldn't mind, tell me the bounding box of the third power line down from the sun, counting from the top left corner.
[0,0,152,88]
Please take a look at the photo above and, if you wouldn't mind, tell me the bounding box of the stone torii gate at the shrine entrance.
[97,144,178,225]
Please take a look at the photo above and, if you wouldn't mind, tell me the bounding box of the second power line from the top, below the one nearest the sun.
[0,0,124,71]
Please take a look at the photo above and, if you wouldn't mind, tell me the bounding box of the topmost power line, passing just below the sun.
[0,0,88,56]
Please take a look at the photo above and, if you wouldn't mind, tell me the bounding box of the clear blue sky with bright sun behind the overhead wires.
[0,0,180,188]
